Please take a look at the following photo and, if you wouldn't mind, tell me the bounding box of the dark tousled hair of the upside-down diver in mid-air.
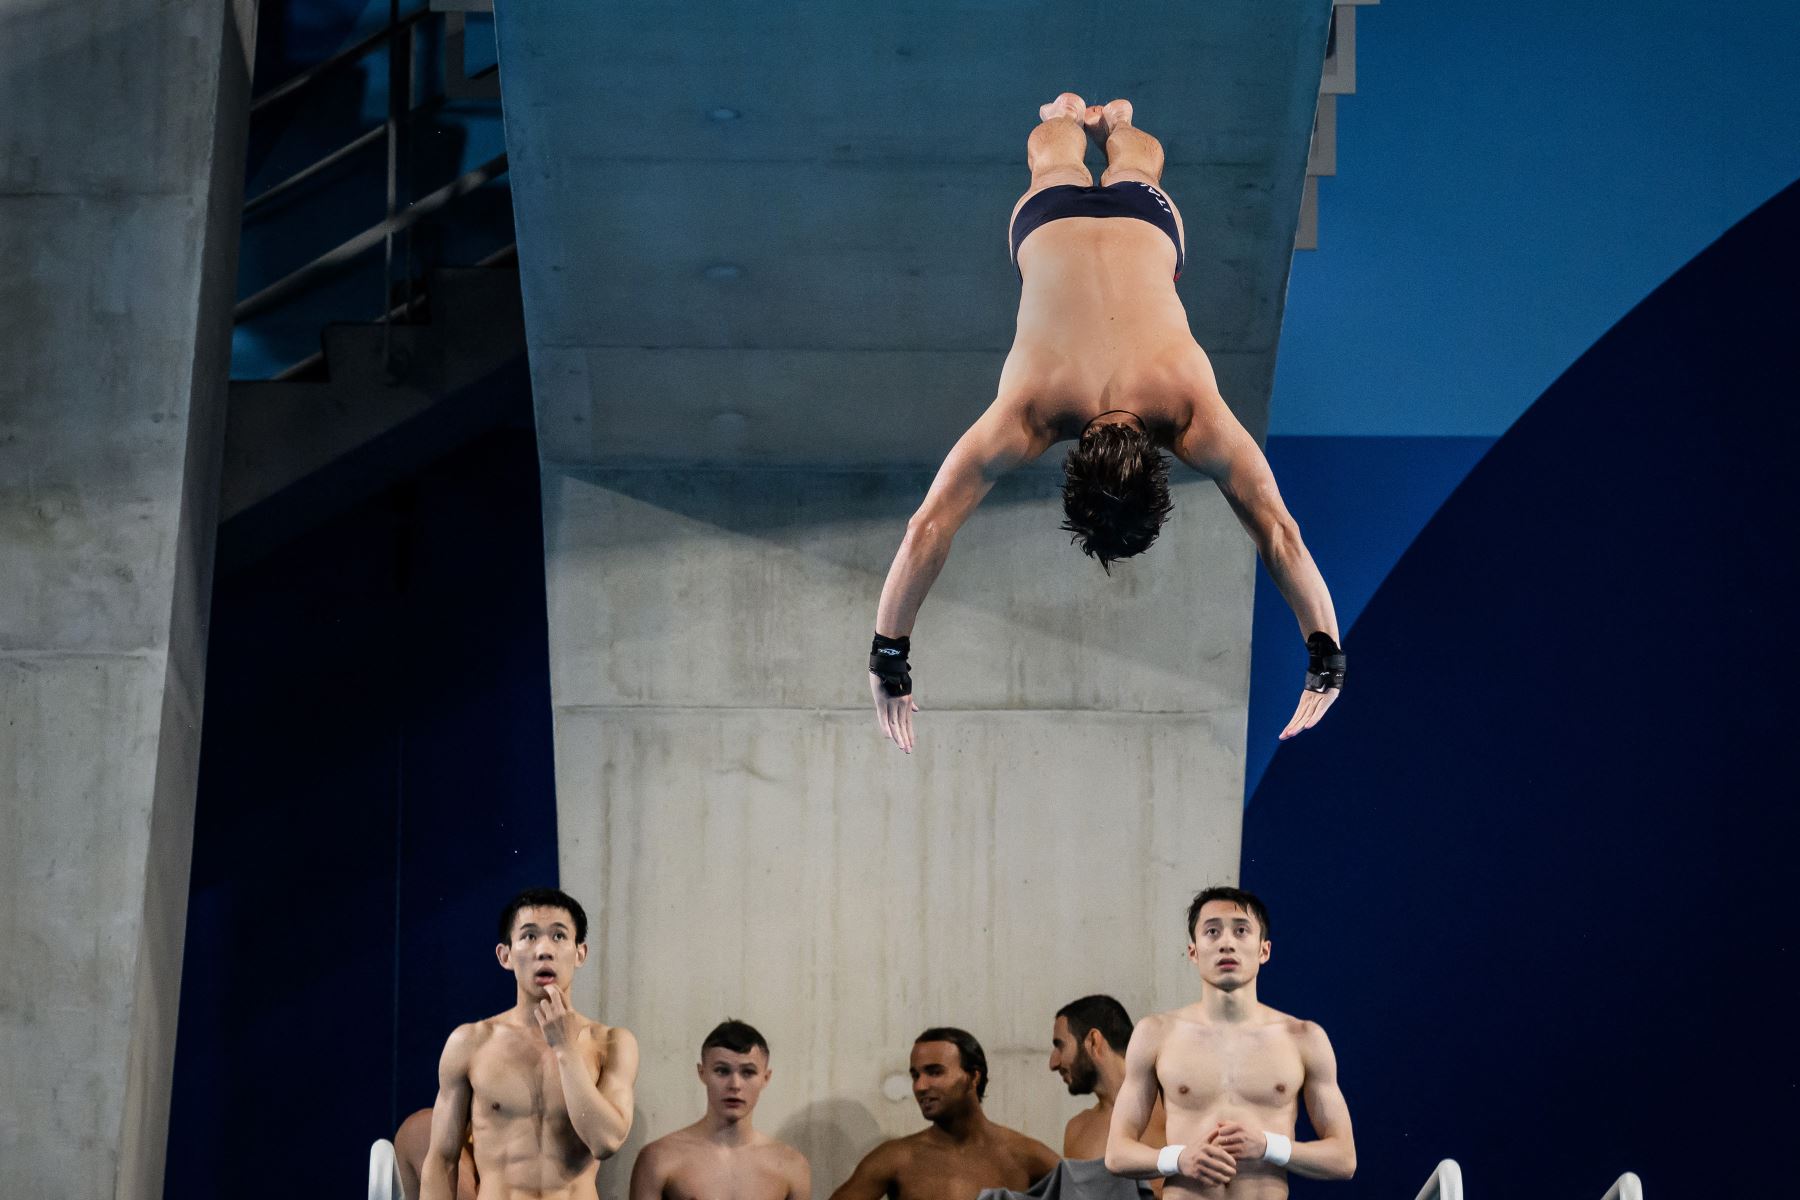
[1062,421,1174,574]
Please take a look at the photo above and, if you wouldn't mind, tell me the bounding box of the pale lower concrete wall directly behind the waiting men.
[544,466,1253,1196]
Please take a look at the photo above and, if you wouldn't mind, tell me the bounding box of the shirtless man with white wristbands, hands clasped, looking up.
[1107,887,1355,1200]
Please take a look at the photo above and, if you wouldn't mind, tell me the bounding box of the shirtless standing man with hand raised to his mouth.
[419,887,637,1200]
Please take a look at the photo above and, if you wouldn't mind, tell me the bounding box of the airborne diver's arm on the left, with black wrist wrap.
[869,399,1049,752]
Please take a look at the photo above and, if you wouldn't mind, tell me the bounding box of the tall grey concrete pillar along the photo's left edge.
[0,0,256,1198]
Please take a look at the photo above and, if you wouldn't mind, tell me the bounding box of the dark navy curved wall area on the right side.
[1244,185,1800,1200]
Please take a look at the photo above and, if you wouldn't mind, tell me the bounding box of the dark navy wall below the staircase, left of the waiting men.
[167,422,556,1200]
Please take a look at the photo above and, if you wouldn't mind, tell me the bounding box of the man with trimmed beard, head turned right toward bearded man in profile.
[832,1027,1057,1200]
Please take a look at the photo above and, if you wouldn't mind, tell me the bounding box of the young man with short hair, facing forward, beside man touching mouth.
[632,1020,812,1200]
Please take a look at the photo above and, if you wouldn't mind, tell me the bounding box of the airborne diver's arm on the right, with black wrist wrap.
[1175,406,1343,739]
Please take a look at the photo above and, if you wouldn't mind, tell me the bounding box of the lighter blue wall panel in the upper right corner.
[1271,0,1800,437]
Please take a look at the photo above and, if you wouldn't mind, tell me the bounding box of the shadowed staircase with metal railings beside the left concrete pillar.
[221,0,527,549]
